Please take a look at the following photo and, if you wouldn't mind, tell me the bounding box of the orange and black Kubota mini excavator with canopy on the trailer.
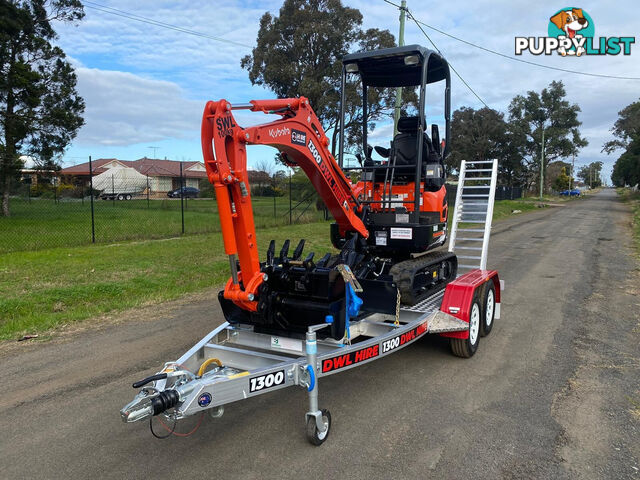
[202,45,458,340]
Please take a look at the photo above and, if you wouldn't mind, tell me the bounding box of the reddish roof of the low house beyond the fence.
[59,157,207,178]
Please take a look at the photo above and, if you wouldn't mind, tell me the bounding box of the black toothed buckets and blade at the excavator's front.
[218,240,397,340]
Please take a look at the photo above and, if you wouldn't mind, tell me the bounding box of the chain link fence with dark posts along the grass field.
[0,163,328,254]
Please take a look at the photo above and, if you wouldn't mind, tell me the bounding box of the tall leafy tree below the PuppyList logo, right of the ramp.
[509,81,588,191]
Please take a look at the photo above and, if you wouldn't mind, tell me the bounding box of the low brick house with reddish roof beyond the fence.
[59,157,207,194]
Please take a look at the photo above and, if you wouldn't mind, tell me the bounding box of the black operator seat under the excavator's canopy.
[391,116,445,191]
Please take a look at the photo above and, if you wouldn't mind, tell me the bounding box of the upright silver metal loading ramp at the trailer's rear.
[449,160,498,275]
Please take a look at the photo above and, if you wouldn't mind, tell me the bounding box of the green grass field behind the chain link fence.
[0,197,322,254]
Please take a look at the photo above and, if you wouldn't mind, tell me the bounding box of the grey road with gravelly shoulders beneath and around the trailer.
[0,190,640,479]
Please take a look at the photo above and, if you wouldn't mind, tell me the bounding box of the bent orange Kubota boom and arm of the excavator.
[201,97,369,312]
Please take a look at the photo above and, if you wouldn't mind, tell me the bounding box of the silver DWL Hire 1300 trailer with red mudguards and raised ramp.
[120,160,504,445]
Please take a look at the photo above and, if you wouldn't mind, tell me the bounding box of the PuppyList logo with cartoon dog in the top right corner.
[516,7,636,57]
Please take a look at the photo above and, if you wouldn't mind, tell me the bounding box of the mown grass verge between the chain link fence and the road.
[0,222,331,340]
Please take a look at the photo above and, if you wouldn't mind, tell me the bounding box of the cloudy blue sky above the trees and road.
[56,0,640,180]
